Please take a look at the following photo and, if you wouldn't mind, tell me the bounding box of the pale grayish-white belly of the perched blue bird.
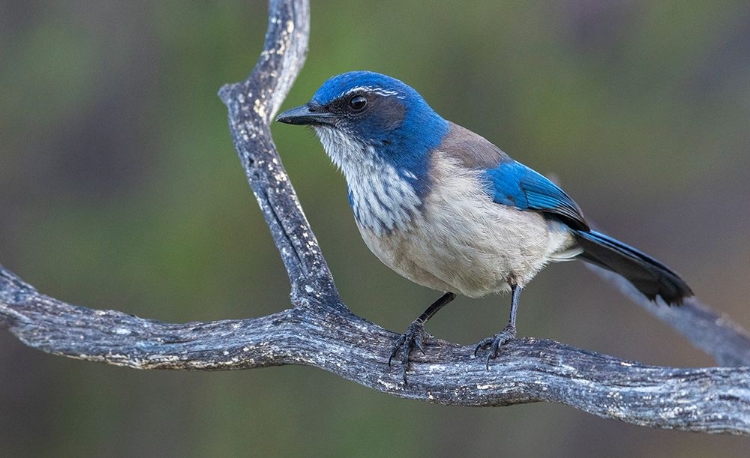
[360,192,574,297]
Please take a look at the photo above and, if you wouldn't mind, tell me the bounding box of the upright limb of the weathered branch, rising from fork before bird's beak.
[219,0,345,310]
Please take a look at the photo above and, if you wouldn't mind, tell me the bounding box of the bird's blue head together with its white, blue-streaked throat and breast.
[278,71,449,233]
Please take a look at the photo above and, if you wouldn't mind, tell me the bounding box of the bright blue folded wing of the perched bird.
[487,160,589,231]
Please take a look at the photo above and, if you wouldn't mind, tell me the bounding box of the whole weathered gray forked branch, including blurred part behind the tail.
[0,0,750,434]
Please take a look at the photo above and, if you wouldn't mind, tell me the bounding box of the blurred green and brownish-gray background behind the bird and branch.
[0,0,750,457]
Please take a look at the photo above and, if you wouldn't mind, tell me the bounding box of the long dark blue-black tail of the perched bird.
[575,231,693,305]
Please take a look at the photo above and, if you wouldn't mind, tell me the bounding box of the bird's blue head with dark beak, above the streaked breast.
[277,71,448,180]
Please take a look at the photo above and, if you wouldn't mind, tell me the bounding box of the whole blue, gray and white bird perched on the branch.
[277,71,693,383]
